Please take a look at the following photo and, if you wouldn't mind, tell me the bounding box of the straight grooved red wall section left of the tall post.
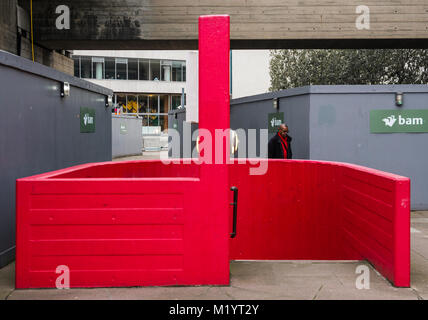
[16,162,207,288]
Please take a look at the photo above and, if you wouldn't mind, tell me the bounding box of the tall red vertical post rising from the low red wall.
[199,15,230,284]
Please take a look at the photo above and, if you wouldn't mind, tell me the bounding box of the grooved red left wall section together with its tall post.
[16,16,234,288]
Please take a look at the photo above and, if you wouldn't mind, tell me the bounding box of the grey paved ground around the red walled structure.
[0,152,428,300]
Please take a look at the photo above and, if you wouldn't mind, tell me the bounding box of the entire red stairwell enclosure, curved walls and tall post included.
[16,16,410,288]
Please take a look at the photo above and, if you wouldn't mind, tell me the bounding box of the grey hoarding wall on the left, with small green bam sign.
[0,52,111,267]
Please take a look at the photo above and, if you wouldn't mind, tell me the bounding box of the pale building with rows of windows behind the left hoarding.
[73,50,197,134]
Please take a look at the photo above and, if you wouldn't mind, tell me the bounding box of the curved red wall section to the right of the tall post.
[230,160,410,287]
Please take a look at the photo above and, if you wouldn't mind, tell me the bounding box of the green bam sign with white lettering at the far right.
[370,110,428,133]
